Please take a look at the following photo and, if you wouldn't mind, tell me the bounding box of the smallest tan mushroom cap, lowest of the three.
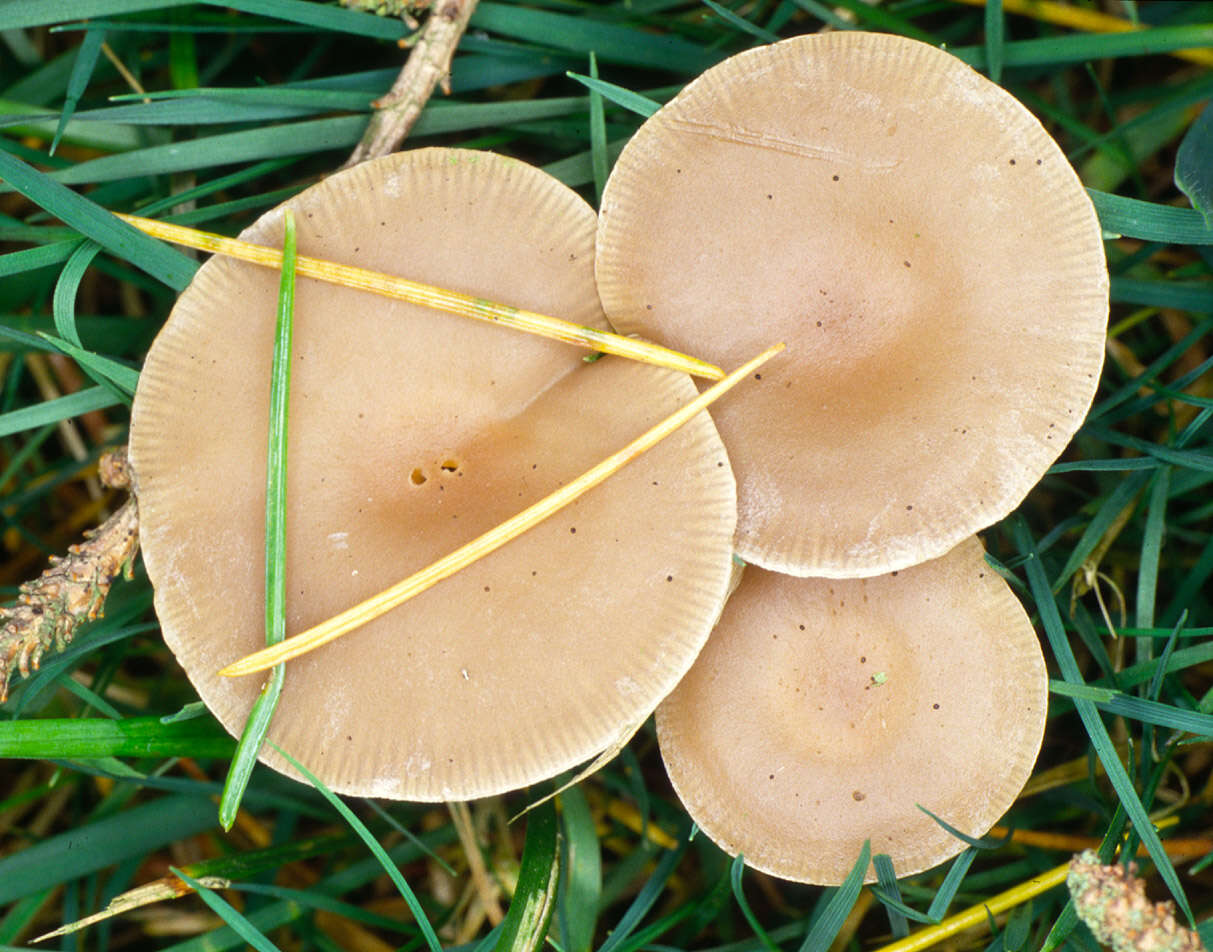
[657,538,1048,884]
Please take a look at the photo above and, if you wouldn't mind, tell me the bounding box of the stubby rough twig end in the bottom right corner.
[1066,850,1205,952]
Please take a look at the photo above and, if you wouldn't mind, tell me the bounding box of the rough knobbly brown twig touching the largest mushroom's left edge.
[0,450,139,703]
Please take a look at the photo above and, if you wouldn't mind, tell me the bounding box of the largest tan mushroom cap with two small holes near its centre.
[131,149,736,800]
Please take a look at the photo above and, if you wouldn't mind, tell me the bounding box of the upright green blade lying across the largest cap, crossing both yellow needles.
[220,209,296,830]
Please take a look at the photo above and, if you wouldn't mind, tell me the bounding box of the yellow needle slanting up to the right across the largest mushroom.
[220,343,784,678]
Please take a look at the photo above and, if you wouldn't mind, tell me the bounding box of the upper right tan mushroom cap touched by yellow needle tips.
[597,32,1107,577]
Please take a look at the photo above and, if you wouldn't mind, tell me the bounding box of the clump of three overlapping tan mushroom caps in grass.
[131,33,1107,883]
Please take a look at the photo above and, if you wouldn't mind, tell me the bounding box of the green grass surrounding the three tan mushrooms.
[0,0,1213,952]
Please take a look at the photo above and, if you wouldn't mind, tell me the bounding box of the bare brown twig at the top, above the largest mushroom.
[343,0,477,169]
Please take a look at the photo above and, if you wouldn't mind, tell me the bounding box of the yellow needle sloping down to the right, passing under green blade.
[118,215,724,380]
